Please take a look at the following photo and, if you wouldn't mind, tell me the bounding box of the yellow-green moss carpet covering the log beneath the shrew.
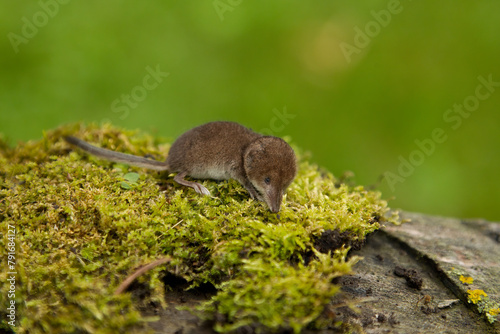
[0,124,397,333]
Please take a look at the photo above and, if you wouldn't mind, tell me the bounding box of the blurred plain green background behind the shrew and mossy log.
[0,0,500,221]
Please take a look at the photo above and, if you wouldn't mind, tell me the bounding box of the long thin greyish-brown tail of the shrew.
[64,136,168,171]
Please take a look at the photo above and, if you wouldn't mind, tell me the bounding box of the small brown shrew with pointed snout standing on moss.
[64,122,297,212]
